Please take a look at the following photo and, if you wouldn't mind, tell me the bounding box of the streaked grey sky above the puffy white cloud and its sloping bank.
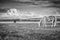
[0,0,60,16]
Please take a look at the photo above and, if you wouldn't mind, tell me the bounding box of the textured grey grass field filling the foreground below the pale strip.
[0,23,60,40]
